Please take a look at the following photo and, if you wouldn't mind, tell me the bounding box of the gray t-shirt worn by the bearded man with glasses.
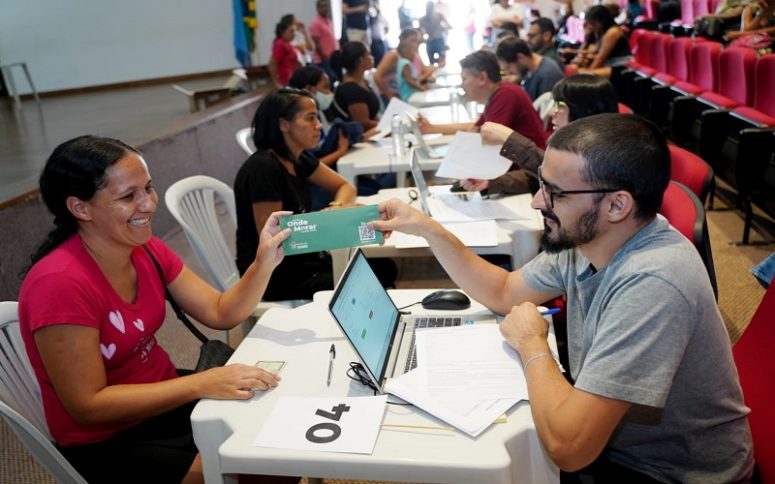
[522,217,753,483]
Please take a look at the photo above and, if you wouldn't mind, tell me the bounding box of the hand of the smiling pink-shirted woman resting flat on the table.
[197,363,280,400]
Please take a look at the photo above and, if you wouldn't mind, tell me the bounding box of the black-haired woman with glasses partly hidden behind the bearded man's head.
[461,74,618,195]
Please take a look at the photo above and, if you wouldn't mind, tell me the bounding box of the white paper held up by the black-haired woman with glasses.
[436,131,511,180]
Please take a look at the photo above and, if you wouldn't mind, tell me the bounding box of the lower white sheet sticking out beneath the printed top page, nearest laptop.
[385,368,517,437]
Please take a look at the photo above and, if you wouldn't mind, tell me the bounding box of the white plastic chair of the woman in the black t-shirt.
[164,175,309,335]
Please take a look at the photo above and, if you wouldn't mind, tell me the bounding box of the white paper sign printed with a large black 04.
[253,395,387,454]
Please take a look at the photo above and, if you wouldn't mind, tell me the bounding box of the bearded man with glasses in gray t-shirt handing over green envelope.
[373,114,753,483]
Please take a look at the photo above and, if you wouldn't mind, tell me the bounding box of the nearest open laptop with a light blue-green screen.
[328,249,495,393]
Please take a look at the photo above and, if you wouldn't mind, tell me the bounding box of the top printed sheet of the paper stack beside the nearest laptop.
[415,324,527,400]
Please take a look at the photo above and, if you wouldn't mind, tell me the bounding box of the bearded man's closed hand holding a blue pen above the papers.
[500,302,549,361]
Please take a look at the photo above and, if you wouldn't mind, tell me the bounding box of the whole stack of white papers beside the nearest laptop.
[386,324,527,437]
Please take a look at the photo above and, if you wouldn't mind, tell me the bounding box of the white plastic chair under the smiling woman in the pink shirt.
[0,301,86,484]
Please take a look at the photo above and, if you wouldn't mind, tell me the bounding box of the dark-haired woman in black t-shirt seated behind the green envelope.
[234,87,355,301]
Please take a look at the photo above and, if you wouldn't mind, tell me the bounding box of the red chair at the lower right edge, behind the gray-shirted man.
[732,283,775,483]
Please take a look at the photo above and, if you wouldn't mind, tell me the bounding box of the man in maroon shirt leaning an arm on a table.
[419,50,546,149]
